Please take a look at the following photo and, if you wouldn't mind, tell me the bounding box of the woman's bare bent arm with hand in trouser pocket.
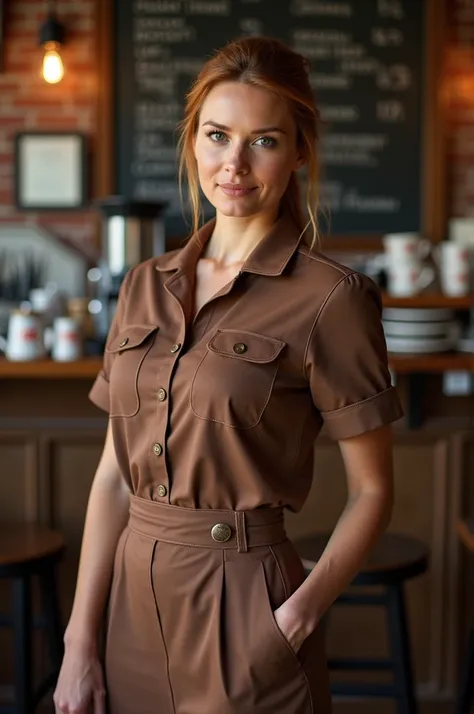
[275,425,393,651]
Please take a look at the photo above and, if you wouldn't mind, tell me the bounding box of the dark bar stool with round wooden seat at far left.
[0,523,64,714]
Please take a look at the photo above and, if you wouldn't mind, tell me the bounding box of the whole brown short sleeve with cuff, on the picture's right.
[305,273,403,440]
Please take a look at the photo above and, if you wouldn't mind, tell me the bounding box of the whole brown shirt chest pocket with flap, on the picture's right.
[191,330,286,429]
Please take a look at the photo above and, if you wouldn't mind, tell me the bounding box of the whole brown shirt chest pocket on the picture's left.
[105,325,159,417]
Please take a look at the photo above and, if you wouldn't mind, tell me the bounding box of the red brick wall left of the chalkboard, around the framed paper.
[0,0,98,250]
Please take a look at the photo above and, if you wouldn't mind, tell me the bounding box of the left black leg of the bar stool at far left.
[13,575,33,714]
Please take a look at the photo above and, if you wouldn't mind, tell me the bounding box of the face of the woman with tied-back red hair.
[194,82,303,218]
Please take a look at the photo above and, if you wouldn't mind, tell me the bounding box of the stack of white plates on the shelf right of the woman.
[382,307,460,354]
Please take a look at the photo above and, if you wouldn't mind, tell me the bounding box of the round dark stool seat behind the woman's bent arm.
[295,533,429,585]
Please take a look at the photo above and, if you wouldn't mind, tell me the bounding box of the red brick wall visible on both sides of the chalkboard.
[0,0,474,244]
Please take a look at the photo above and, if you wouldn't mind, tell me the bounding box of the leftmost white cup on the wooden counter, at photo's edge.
[0,310,46,362]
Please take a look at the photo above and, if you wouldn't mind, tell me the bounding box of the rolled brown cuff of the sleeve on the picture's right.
[321,387,403,440]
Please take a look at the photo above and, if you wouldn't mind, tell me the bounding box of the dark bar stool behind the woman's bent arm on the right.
[295,533,428,714]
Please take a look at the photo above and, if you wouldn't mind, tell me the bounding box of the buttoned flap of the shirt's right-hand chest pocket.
[207,330,286,363]
